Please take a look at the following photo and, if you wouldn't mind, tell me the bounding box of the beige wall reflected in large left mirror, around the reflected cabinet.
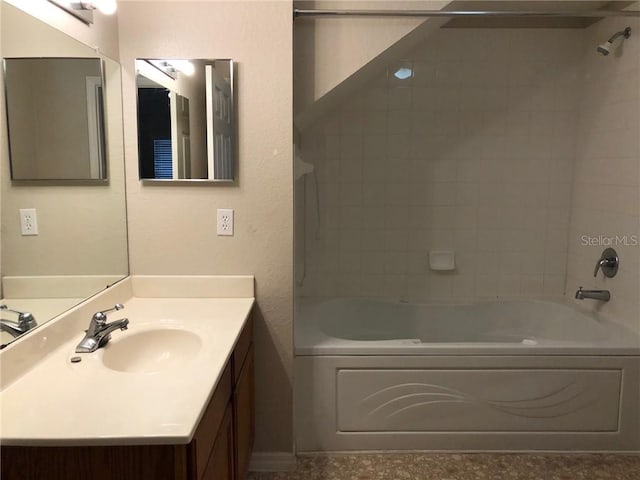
[0,2,128,275]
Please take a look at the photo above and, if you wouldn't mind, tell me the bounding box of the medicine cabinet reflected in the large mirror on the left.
[4,58,107,180]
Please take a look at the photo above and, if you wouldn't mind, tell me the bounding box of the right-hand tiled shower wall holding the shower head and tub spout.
[567,15,640,331]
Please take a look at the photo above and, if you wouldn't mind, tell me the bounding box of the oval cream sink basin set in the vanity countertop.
[102,328,202,373]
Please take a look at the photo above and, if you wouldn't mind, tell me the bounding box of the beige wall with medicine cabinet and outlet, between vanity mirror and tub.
[119,1,293,452]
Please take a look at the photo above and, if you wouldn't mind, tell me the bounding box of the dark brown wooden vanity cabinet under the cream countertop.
[0,318,254,480]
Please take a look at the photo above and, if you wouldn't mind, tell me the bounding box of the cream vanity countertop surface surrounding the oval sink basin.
[0,277,254,446]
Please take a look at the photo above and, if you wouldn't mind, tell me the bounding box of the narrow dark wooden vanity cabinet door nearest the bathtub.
[233,344,255,480]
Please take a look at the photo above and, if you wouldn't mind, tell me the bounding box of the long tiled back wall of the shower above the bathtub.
[296,29,584,299]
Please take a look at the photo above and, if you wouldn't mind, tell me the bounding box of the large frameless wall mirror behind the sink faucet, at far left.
[0,2,129,347]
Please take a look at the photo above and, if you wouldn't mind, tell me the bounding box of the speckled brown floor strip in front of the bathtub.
[248,453,640,480]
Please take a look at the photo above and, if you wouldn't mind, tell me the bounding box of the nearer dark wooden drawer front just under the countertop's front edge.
[191,364,232,479]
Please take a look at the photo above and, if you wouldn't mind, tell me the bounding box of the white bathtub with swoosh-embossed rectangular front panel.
[295,299,640,452]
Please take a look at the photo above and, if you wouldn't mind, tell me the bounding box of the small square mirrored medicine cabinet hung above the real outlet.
[136,59,236,182]
